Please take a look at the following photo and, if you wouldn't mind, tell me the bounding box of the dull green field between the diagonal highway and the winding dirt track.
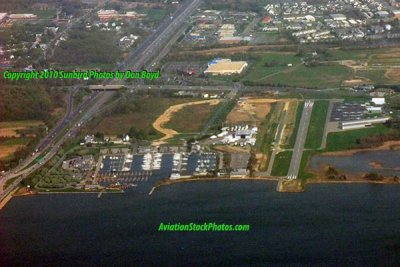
[90,97,194,136]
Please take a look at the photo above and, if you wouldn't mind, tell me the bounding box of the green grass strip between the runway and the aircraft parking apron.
[304,100,329,149]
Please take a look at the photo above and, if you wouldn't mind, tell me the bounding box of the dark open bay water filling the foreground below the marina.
[0,181,400,266]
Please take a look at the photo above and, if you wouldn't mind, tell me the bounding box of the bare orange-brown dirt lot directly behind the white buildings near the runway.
[226,98,276,124]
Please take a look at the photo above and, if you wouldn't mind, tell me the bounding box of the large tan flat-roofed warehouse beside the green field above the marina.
[204,59,247,75]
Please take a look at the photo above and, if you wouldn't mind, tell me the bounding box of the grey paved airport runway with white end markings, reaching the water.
[287,100,314,180]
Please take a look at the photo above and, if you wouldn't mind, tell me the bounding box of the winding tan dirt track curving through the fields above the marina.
[152,99,220,146]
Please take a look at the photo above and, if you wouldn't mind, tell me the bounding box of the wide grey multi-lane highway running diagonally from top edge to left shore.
[0,0,201,201]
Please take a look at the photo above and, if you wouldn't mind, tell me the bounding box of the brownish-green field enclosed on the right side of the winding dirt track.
[164,103,217,133]
